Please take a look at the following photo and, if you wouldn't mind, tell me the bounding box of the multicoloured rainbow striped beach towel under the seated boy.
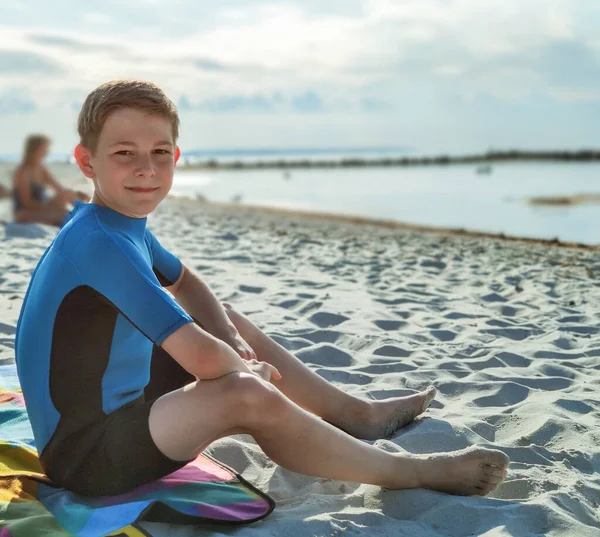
[0,365,275,537]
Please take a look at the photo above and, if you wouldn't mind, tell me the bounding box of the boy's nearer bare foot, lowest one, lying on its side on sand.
[417,447,509,496]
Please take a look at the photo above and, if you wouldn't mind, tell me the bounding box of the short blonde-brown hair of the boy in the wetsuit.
[77,80,179,153]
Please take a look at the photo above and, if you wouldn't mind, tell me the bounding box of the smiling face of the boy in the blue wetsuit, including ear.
[75,108,179,218]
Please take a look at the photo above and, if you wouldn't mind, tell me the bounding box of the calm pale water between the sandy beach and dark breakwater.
[173,163,600,244]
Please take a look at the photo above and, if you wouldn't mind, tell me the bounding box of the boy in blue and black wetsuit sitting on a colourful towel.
[16,81,508,496]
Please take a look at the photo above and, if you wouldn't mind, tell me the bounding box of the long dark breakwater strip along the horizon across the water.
[179,149,600,170]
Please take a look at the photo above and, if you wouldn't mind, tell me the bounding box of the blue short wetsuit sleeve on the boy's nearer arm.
[75,232,193,345]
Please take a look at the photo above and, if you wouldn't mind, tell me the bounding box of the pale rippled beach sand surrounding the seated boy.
[0,173,600,537]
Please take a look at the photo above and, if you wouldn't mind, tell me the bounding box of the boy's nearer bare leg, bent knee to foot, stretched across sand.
[149,372,508,495]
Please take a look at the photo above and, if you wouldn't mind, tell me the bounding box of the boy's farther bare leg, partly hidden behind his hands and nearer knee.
[224,304,436,440]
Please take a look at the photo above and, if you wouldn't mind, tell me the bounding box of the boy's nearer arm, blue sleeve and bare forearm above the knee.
[77,231,252,379]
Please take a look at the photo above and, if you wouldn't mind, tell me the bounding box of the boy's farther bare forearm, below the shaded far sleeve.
[167,264,250,354]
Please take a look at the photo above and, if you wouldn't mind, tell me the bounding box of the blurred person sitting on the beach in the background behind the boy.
[13,134,90,226]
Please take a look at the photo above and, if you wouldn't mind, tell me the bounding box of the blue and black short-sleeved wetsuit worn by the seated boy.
[16,204,193,495]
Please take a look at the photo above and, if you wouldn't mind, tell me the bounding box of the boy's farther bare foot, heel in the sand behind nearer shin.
[334,386,437,440]
